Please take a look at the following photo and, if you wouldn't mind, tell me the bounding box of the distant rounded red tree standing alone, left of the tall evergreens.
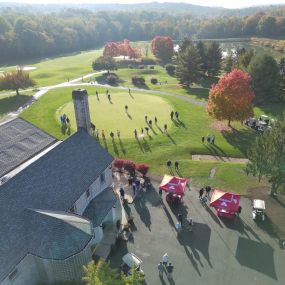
[151,36,173,61]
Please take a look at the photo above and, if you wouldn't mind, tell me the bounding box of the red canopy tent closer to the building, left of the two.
[159,175,187,202]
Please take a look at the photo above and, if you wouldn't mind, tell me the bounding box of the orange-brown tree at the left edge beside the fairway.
[0,69,36,95]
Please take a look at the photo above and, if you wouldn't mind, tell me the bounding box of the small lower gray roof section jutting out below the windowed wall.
[83,187,117,227]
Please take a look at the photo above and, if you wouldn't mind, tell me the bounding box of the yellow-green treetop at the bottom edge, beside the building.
[82,259,122,285]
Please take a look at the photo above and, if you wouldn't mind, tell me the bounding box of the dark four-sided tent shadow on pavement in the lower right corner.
[235,237,277,280]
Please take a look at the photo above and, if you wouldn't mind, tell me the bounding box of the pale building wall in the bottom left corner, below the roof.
[0,254,43,285]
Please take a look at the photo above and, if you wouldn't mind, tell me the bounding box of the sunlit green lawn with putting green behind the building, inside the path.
[21,87,268,193]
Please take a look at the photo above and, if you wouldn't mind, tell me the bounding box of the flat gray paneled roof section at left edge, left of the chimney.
[0,118,56,177]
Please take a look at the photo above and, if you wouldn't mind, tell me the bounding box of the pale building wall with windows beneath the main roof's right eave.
[75,165,113,215]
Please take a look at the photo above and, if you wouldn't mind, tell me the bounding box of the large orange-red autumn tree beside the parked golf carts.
[207,69,254,126]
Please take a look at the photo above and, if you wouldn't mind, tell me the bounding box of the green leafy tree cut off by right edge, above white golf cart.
[246,113,285,195]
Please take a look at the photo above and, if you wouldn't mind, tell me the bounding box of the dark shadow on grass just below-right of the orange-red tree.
[222,129,256,156]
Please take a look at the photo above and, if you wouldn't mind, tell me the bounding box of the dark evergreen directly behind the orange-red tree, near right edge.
[248,54,281,102]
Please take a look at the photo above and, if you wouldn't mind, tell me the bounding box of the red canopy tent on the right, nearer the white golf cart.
[210,189,240,218]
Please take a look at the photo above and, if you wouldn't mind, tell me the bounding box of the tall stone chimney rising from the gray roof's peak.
[72,89,91,134]
